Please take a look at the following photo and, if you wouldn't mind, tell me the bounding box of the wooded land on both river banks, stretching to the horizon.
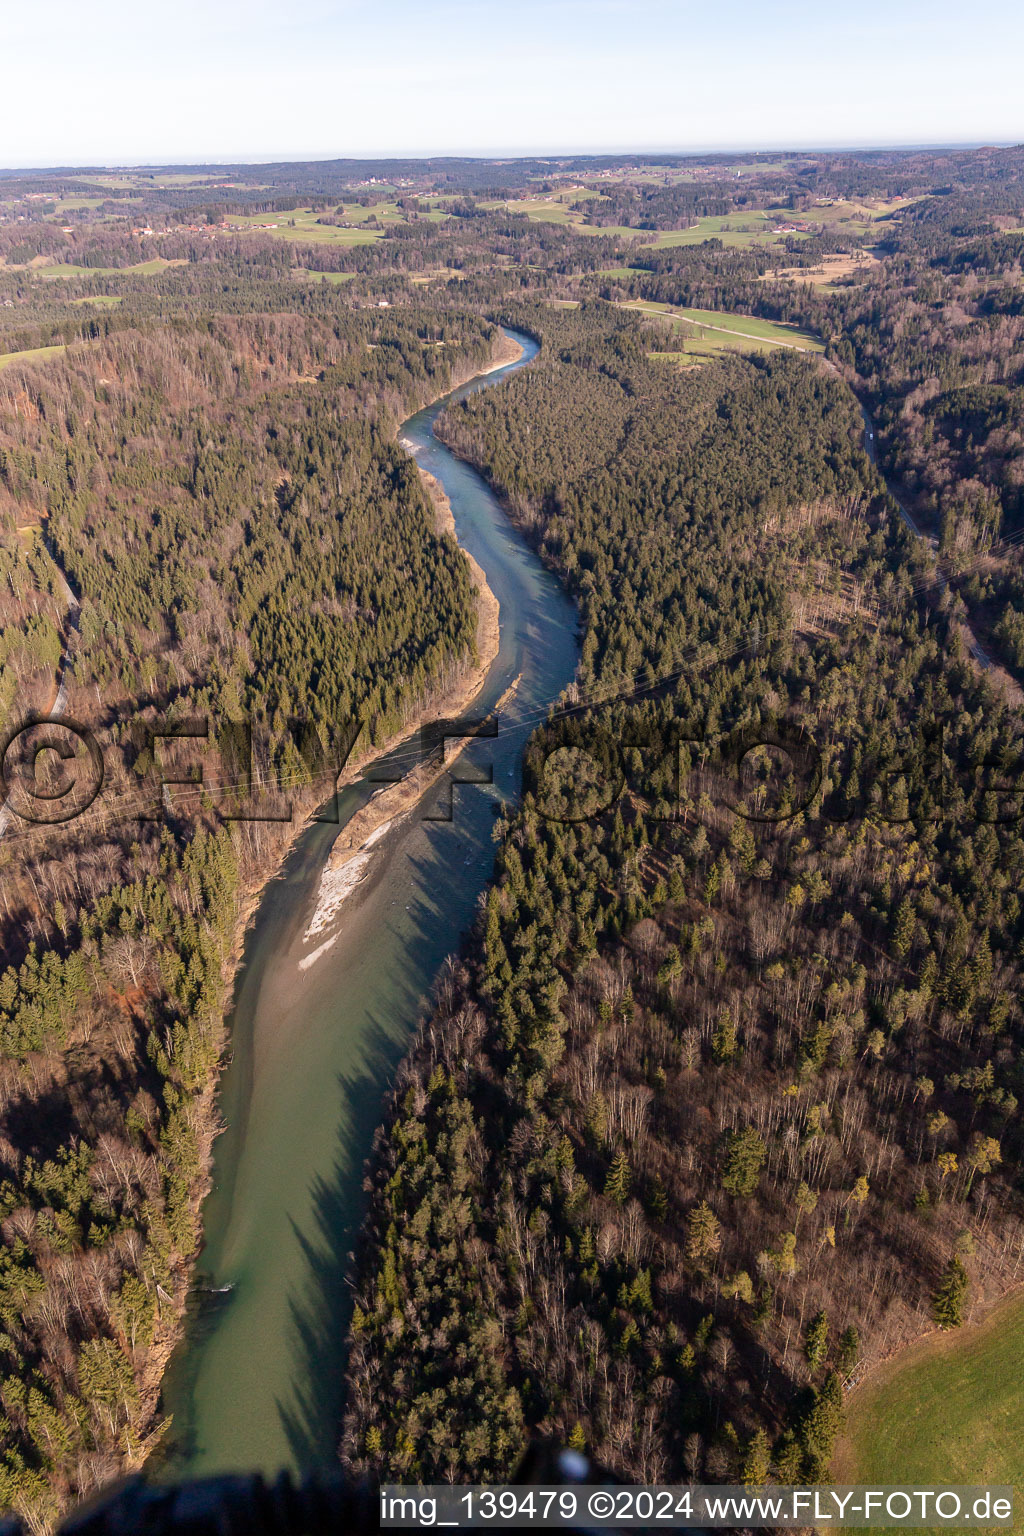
[0,151,1024,1530]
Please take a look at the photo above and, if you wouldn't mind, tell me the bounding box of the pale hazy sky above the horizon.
[0,0,1024,166]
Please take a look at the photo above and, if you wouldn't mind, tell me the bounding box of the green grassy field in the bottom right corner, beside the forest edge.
[832,1292,1024,1531]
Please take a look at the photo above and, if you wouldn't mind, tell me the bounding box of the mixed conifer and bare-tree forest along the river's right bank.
[344,306,1024,1482]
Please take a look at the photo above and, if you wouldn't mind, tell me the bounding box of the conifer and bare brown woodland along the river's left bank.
[0,299,509,1525]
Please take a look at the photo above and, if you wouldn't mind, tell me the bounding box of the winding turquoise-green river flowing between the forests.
[161,335,579,1476]
